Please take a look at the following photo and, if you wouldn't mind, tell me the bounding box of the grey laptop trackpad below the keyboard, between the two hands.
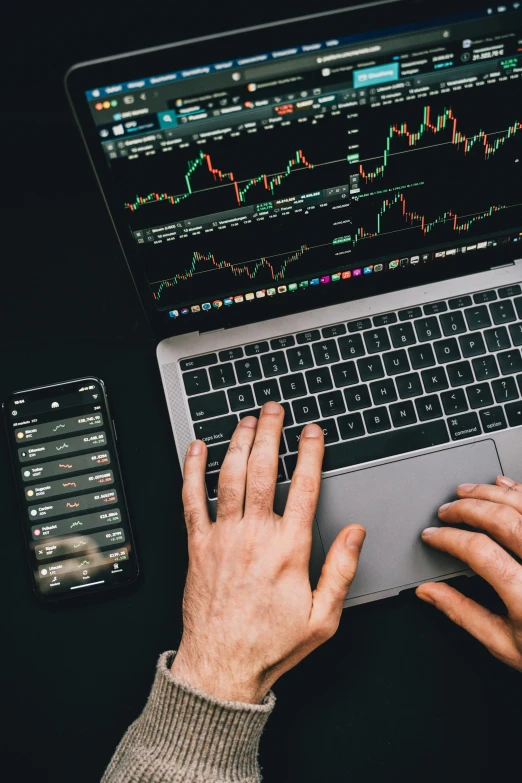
[317,440,502,605]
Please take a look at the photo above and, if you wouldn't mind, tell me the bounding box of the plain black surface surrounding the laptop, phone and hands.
[0,0,522,783]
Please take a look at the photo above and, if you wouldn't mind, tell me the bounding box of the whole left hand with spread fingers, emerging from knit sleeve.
[171,402,365,703]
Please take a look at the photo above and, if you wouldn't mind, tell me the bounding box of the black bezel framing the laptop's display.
[65,0,520,339]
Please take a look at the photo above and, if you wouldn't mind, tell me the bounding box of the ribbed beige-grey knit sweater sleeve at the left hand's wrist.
[102,652,275,783]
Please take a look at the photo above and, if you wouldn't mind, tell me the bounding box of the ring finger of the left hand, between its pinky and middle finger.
[216,416,257,522]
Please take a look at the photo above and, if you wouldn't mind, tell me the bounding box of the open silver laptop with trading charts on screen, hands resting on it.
[66,0,522,606]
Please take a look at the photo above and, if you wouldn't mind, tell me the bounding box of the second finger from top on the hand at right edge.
[439,494,522,556]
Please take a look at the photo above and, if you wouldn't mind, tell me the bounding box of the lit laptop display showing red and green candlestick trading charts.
[80,2,522,331]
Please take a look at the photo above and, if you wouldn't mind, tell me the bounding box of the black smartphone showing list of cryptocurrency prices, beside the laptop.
[3,378,138,601]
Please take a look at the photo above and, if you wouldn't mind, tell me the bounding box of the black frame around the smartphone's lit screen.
[2,376,139,604]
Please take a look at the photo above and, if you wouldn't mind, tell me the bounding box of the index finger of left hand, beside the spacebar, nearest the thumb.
[283,424,324,543]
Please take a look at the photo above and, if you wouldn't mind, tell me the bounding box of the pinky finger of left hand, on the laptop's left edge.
[182,440,211,539]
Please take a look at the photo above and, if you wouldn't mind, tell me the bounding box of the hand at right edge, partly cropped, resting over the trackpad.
[416,476,522,671]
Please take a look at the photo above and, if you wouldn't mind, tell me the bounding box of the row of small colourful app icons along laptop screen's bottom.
[158,231,522,318]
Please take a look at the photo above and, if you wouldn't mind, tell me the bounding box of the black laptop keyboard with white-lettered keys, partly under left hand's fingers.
[180,284,522,499]
